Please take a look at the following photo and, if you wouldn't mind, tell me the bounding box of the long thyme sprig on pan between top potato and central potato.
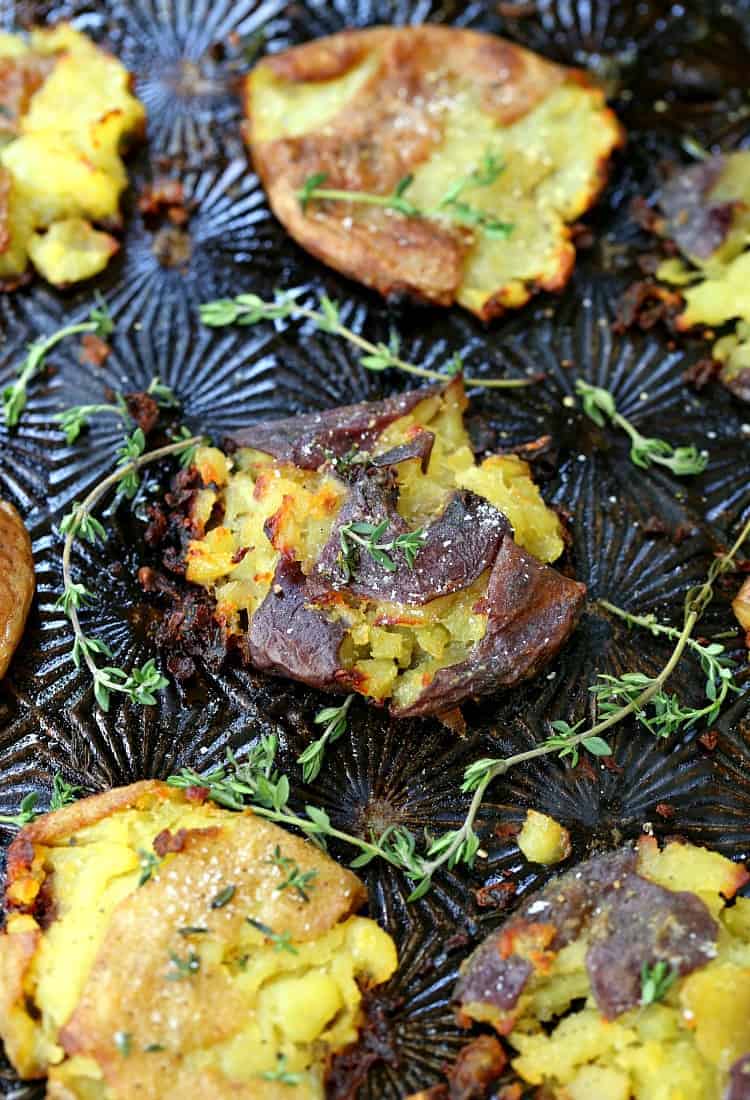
[200,290,537,389]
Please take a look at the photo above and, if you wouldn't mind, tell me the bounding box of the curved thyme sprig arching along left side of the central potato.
[56,429,201,711]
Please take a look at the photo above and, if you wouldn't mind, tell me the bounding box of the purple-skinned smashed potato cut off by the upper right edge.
[655,152,750,402]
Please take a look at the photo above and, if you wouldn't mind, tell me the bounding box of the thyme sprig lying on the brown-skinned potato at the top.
[297,151,515,240]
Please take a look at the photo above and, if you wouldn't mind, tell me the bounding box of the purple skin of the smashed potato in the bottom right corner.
[455,848,718,1020]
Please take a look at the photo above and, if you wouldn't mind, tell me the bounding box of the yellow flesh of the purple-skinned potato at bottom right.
[488,844,750,1100]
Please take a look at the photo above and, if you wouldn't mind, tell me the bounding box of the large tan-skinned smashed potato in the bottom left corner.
[0,781,397,1100]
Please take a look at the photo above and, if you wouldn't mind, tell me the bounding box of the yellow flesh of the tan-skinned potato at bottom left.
[8,802,397,1100]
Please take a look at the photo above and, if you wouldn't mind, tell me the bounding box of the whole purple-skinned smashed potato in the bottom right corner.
[456,837,750,1100]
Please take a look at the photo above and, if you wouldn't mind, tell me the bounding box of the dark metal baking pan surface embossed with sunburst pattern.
[0,0,750,1100]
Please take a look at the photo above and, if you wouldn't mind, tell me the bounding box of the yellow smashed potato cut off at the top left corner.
[0,24,145,287]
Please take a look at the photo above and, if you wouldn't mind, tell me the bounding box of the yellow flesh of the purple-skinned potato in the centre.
[186,387,563,706]
